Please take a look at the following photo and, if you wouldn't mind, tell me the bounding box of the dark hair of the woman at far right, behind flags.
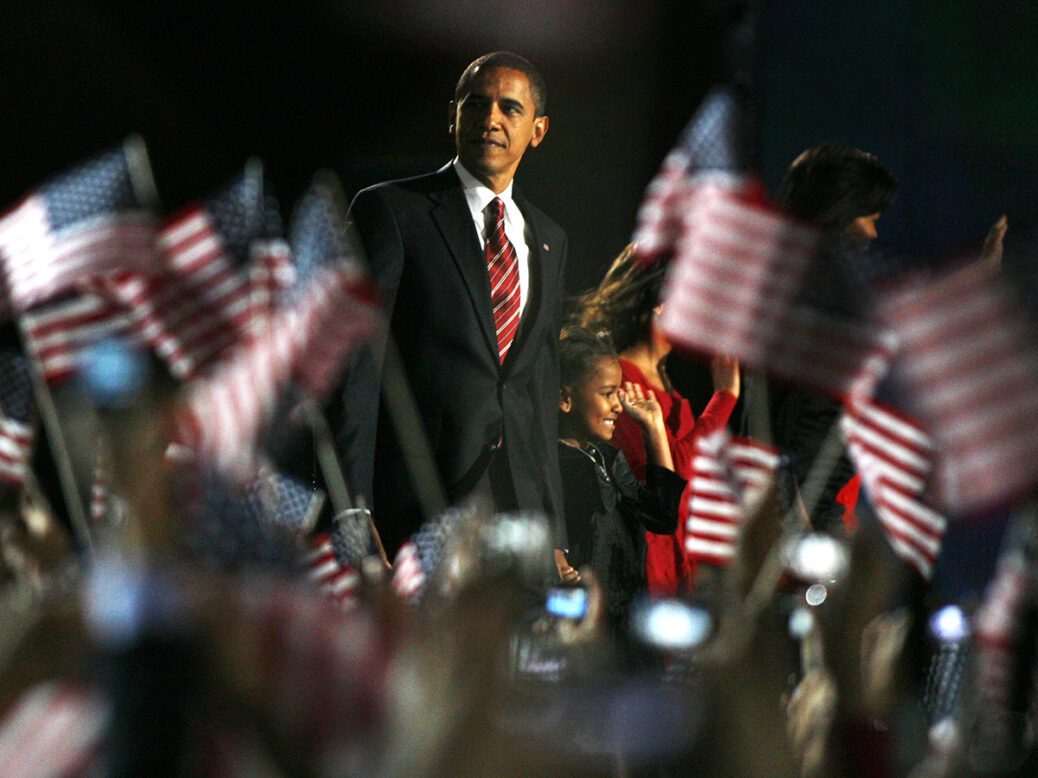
[777,143,898,233]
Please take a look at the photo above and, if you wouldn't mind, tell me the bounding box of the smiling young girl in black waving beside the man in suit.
[556,328,685,628]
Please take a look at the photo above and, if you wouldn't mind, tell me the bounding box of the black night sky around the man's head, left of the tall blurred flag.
[0,0,731,287]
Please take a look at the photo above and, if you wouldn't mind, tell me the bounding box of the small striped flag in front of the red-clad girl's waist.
[685,429,779,565]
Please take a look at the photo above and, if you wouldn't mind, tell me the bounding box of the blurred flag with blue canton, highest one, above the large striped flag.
[633,87,750,260]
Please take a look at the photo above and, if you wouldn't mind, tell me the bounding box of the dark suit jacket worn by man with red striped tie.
[337,165,566,550]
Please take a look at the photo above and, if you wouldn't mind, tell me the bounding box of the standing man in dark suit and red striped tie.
[338,52,566,553]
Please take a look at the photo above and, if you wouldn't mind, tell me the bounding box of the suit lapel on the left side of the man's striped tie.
[431,166,497,355]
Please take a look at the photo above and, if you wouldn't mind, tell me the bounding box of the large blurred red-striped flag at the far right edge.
[879,263,1038,513]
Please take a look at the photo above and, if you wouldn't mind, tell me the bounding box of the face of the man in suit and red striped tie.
[450,67,548,192]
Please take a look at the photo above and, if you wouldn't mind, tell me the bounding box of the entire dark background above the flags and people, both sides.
[0,0,1038,597]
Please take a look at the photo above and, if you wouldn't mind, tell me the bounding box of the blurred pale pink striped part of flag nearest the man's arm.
[183,251,378,478]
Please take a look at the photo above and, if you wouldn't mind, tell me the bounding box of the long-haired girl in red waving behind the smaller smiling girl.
[576,245,739,595]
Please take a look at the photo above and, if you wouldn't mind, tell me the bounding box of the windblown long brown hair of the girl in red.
[573,244,665,353]
